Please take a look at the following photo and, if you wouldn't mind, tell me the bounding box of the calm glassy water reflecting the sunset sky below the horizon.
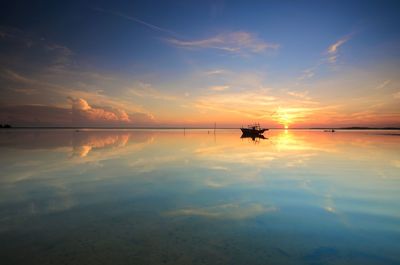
[0,130,400,264]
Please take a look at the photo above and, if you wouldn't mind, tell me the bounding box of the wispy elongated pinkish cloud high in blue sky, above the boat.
[167,31,279,53]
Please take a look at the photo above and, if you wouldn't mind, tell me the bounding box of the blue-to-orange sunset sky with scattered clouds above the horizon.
[0,0,400,128]
